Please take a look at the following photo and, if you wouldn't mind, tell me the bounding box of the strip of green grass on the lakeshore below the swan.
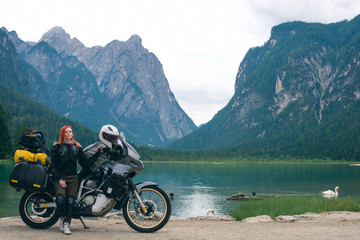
[231,196,360,220]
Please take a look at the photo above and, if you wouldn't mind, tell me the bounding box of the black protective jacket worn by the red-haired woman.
[50,143,99,181]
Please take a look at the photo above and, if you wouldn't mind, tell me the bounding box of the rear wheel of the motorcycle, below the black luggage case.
[19,192,59,229]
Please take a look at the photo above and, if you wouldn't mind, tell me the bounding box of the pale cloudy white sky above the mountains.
[0,0,360,125]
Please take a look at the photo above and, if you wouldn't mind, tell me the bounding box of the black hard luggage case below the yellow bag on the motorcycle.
[9,162,49,192]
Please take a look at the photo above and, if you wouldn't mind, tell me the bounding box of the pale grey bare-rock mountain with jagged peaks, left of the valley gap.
[40,27,196,145]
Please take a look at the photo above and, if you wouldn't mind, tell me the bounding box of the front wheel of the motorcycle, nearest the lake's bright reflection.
[123,186,171,233]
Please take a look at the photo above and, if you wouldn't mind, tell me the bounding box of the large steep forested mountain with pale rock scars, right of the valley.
[169,15,360,160]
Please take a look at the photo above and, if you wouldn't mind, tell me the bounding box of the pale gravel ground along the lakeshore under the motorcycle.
[0,212,360,240]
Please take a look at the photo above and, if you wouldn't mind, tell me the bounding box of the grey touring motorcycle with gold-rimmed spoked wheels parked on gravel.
[11,134,171,233]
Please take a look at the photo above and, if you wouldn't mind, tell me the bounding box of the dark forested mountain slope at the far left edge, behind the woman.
[0,30,97,147]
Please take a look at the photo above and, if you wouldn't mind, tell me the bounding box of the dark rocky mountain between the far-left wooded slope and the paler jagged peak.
[2,29,116,131]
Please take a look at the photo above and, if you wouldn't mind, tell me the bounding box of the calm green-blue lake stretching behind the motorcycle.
[0,161,360,218]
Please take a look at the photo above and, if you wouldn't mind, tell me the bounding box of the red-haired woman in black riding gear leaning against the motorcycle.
[50,126,87,235]
